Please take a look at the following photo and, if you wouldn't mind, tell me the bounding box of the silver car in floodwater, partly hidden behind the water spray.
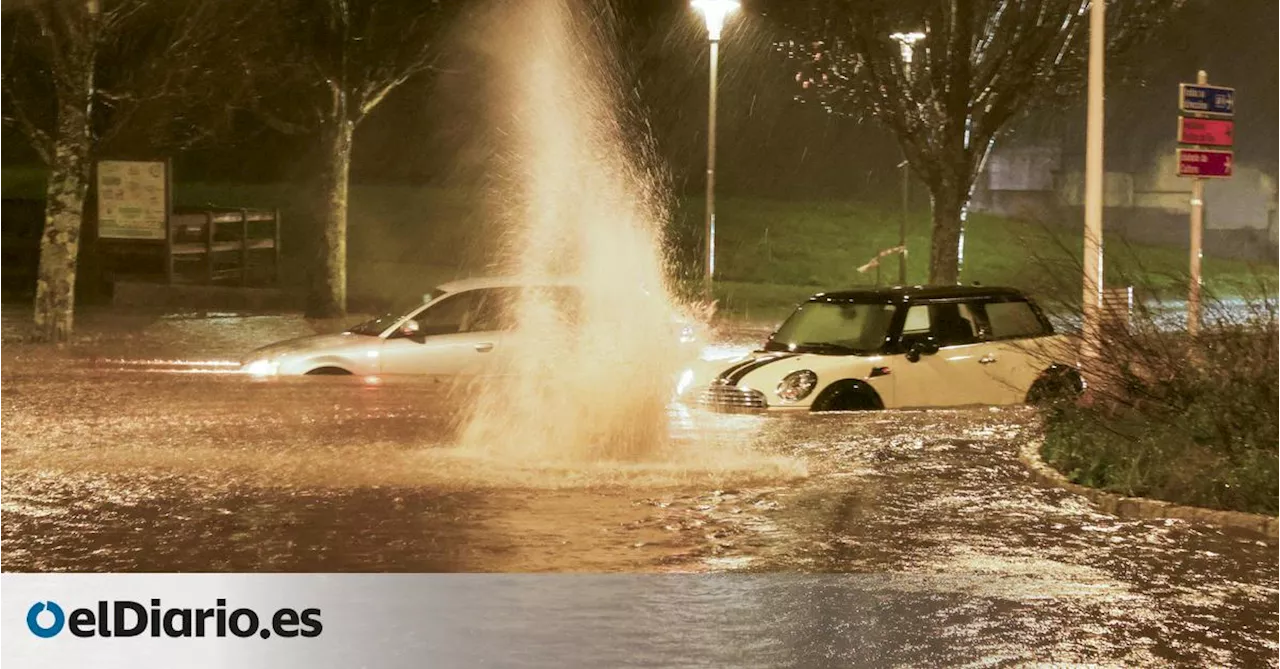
[241,278,695,376]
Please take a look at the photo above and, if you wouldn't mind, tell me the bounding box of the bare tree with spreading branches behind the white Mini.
[776,0,1183,284]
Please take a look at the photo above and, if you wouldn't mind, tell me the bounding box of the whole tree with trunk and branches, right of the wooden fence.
[243,0,462,317]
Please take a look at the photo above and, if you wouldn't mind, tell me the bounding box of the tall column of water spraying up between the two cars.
[463,0,701,462]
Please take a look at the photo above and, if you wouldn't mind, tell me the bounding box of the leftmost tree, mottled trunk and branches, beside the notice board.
[0,0,243,343]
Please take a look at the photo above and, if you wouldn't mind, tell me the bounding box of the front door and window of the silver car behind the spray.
[381,288,511,376]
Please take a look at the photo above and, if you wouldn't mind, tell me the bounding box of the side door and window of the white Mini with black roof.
[893,301,1000,407]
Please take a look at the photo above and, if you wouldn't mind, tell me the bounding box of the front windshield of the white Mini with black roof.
[764,302,896,354]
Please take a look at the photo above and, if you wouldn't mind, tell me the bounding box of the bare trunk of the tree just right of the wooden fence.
[307,119,356,319]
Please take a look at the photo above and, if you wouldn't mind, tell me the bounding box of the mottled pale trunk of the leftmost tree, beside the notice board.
[35,50,93,343]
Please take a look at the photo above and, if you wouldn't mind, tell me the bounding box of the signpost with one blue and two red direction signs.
[1178,70,1235,336]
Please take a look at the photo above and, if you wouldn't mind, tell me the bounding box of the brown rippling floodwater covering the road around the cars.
[0,310,1280,666]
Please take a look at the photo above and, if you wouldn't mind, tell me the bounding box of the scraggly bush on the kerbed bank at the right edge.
[1043,290,1280,514]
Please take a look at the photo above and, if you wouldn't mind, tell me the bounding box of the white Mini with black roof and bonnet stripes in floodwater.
[687,285,1083,412]
